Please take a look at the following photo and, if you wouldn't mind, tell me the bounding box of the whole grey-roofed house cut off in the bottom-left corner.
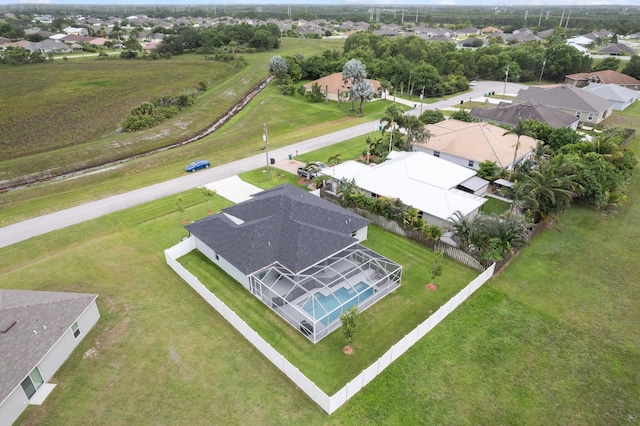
[0,289,100,425]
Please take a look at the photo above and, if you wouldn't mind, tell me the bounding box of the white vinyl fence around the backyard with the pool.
[164,237,495,414]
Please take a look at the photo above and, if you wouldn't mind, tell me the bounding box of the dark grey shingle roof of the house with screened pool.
[185,184,369,275]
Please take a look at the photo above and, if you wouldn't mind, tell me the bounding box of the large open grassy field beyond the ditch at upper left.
[0,39,344,180]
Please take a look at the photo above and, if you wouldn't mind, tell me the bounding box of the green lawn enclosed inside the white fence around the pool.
[180,226,477,395]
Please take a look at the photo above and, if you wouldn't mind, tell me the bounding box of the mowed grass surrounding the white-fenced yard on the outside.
[0,112,640,425]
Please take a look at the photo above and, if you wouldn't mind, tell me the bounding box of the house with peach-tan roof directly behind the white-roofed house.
[413,120,536,170]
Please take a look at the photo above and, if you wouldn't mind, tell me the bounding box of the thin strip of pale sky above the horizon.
[5,0,640,7]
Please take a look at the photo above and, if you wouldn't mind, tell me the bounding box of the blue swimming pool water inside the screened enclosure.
[298,282,373,325]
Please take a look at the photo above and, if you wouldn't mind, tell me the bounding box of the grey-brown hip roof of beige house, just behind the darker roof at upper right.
[513,84,613,114]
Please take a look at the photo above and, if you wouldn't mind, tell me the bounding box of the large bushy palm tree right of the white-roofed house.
[522,156,580,226]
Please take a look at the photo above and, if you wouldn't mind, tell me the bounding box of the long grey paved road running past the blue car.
[0,82,524,248]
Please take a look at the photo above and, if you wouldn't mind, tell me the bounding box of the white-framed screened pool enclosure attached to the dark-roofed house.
[249,244,402,343]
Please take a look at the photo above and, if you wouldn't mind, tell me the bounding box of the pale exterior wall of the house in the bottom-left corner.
[0,300,100,426]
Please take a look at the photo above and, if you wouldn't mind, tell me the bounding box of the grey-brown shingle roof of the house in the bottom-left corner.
[0,289,98,402]
